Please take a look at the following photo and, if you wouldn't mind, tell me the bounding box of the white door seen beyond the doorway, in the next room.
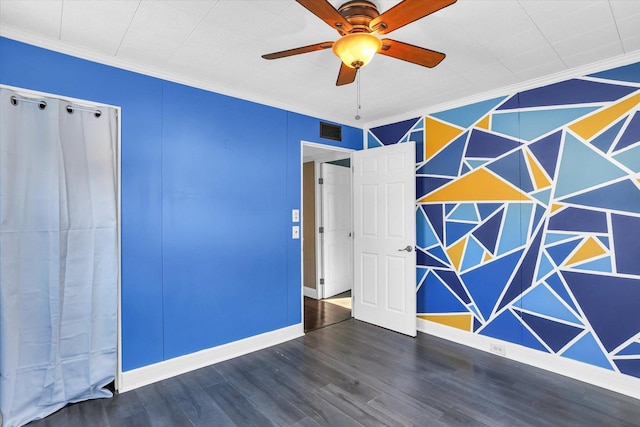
[320,163,353,298]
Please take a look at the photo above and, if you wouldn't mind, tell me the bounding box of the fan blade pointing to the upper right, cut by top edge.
[369,0,457,34]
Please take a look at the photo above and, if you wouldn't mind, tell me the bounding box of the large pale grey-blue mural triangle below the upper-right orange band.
[554,133,628,198]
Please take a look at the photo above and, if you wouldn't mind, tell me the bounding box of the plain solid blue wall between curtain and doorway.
[0,38,362,371]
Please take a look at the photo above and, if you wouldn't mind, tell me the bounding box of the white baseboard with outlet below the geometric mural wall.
[417,318,640,399]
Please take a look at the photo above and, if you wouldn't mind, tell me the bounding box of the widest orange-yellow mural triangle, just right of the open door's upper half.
[418,169,531,203]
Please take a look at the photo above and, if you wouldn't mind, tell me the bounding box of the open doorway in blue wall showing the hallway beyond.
[301,141,353,332]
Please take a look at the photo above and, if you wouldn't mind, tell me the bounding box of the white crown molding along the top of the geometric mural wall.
[363,50,640,129]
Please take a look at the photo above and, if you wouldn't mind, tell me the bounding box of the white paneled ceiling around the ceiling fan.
[0,0,640,127]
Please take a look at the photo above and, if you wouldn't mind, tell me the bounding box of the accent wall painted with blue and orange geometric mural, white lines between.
[368,64,640,378]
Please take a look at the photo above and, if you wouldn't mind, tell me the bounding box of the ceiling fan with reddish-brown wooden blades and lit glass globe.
[262,0,456,86]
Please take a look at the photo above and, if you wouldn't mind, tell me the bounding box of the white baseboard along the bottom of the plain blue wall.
[118,323,304,393]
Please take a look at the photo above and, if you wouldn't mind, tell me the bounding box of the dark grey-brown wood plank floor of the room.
[30,319,640,427]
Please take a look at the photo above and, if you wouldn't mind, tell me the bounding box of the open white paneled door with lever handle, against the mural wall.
[352,142,416,336]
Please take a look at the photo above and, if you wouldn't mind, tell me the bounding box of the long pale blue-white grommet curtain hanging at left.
[0,88,118,427]
